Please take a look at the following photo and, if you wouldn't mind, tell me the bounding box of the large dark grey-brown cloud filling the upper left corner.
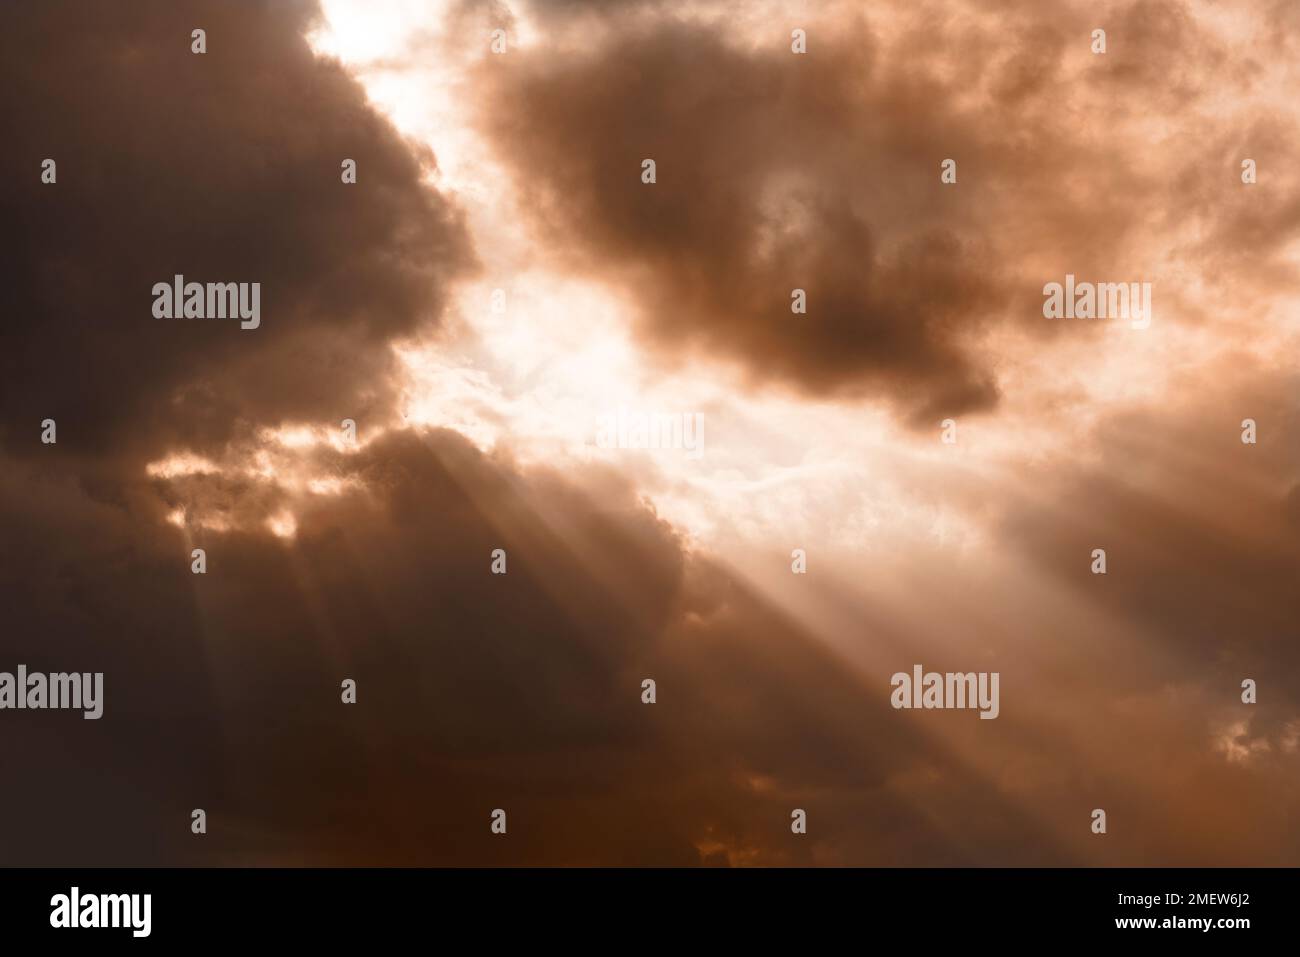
[0,3,471,454]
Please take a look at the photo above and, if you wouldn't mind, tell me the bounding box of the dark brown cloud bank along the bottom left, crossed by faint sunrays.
[0,430,1052,863]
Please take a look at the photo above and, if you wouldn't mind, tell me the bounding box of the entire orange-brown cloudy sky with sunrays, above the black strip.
[0,0,1300,866]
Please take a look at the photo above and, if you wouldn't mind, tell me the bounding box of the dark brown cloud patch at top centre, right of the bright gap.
[482,15,1002,413]
